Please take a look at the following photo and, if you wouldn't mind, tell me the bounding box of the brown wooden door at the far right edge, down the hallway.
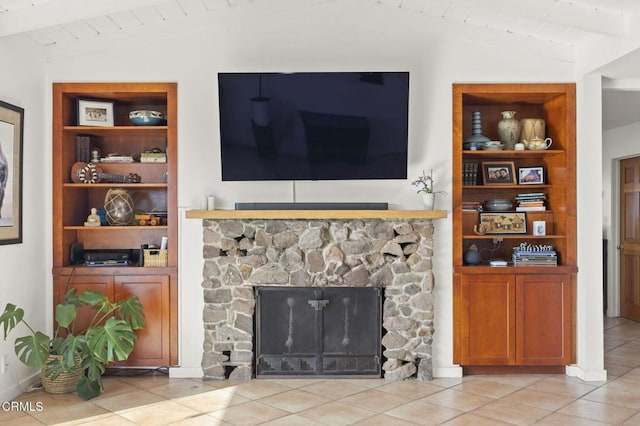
[619,157,640,322]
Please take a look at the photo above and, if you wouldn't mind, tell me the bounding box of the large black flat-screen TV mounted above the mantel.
[218,72,409,181]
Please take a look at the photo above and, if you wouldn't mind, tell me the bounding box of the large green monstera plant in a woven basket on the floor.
[0,277,145,400]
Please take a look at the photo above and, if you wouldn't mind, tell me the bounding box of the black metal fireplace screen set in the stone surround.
[255,287,382,377]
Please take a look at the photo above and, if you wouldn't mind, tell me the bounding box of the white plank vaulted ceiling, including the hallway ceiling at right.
[0,0,640,129]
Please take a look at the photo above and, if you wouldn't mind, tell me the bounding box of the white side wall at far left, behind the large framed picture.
[0,37,47,401]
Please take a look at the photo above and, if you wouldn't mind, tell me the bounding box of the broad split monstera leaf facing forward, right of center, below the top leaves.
[86,317,137,363]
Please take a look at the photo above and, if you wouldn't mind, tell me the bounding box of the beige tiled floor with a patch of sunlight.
[0,319,640,426]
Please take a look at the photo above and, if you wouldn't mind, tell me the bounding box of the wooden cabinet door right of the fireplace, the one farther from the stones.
[516,274,571,365]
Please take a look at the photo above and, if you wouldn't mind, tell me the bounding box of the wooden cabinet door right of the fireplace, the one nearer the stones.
[460,274,516,365]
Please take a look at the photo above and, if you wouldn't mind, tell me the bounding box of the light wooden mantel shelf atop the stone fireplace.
[186,210,447,220]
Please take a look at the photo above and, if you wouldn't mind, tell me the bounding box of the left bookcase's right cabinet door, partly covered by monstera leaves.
[115,275,170,366]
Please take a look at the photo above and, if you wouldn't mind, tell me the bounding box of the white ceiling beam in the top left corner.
[0,0,176,37]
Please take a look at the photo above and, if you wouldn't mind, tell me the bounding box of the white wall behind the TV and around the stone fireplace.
[46,2,576,377]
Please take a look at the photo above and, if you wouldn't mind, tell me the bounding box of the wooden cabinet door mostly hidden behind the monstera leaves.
[54,275,113,334]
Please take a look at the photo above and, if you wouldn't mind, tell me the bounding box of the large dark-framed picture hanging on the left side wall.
[0,101,24,244]
